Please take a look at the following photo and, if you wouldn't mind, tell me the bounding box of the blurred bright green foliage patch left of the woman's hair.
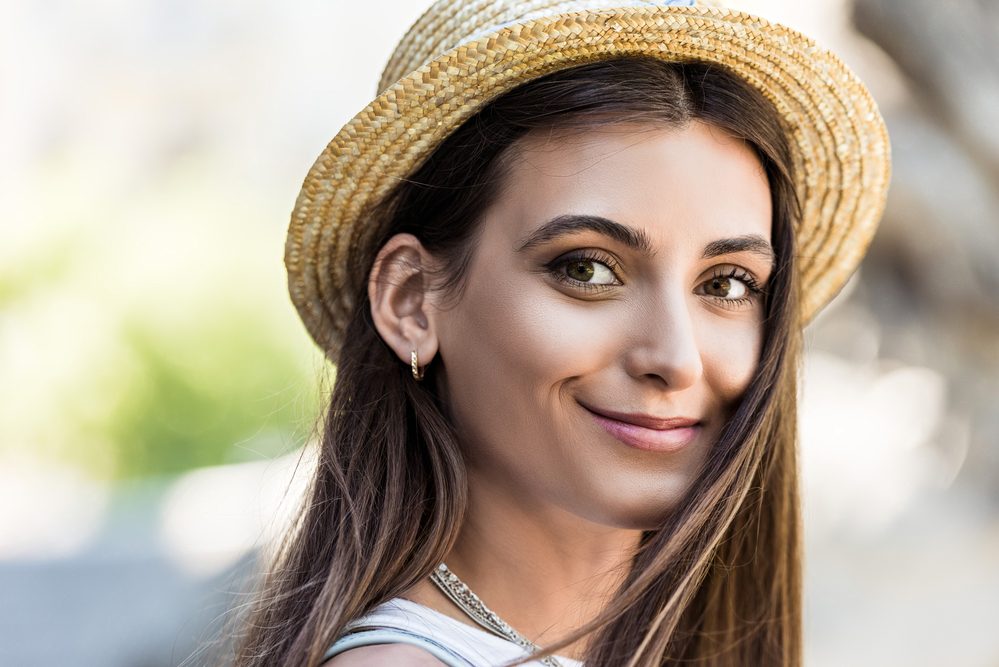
[107,310,319,477]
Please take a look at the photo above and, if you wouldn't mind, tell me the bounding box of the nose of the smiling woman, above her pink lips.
[624,294,704,391]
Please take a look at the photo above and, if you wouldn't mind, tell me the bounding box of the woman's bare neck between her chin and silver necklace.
[410,472,641,657]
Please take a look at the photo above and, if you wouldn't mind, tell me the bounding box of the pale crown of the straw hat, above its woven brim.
[378,0,700,94]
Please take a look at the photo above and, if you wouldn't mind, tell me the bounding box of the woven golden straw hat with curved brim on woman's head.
[285,0,890,360]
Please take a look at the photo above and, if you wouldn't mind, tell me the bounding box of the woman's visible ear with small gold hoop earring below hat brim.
[368,234,438,366]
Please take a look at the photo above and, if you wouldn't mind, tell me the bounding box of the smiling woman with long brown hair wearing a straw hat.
[236,0,888,667]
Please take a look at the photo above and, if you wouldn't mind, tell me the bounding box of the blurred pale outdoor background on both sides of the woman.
[0,0,999,667]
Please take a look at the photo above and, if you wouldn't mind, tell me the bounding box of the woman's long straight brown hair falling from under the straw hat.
[234,57,801,667]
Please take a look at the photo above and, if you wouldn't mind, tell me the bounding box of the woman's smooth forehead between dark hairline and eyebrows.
[488,121,771,245]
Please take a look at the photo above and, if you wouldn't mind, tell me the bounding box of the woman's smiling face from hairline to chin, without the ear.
[437,122,773,529]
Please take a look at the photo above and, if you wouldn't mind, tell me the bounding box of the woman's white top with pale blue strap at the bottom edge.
[324,598,583,667]
